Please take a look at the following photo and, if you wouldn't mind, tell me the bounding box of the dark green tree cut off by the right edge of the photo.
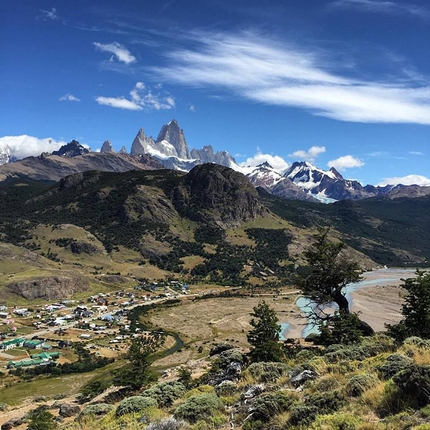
[388,269,430,340]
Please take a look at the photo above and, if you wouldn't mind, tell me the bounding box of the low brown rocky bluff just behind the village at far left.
[8,275,89,300]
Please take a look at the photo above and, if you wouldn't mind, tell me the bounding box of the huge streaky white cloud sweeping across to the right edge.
[151,32,430,124]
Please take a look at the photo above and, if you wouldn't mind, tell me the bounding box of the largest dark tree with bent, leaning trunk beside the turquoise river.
[296,228,373,340]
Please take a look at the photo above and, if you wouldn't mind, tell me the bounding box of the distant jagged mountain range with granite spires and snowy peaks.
[0,120,430,203]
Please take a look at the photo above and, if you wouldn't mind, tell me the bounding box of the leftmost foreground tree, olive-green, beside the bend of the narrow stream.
[114,337,157,390]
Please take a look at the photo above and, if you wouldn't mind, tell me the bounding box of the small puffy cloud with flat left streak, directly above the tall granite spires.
[96,82,175,110]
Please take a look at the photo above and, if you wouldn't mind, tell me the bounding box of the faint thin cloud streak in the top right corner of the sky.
[329,0,430,19]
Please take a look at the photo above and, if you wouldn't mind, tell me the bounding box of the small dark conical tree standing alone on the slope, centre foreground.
[247,301,283,362]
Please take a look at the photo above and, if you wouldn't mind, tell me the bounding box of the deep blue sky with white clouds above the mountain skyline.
[0,0,430,185]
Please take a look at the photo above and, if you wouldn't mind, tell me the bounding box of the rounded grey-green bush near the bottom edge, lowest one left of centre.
[173,393,224,423]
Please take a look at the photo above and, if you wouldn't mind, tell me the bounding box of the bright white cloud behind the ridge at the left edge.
[0,134,66,159]
